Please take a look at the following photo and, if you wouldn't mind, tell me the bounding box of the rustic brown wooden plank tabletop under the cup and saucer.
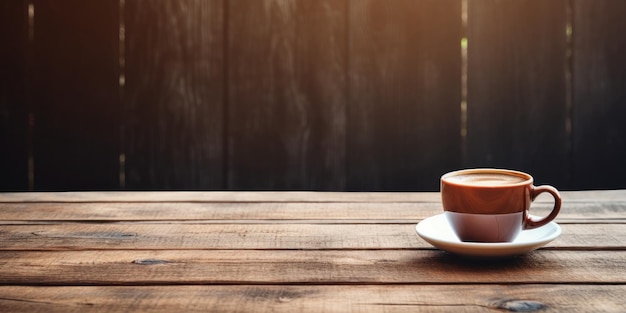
[0,190,626,313]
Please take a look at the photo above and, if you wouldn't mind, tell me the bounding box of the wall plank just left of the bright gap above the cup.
[347,0,461,191]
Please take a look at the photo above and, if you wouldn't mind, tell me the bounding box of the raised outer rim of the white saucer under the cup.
[415,213,561,257]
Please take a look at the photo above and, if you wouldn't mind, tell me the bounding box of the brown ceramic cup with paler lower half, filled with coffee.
[441,168,561,242]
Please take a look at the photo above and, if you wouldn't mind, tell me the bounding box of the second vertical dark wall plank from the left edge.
[29,0,119,190]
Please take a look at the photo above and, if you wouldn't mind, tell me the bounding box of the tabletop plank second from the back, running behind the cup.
[0,201,626,224]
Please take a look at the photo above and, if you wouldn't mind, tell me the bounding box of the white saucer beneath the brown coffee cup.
[415,214,561,257]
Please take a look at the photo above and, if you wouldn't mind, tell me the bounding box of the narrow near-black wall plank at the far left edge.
[0,0,28,191]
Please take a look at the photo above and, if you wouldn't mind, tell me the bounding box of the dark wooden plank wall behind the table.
[0,0,626,190]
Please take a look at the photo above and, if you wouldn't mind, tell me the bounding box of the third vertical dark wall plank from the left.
[123,0,225,190]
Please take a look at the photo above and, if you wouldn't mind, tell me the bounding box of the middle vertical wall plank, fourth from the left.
[228,0,346,190]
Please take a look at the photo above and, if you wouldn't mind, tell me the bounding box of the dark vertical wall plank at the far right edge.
[573,0,626,189]
